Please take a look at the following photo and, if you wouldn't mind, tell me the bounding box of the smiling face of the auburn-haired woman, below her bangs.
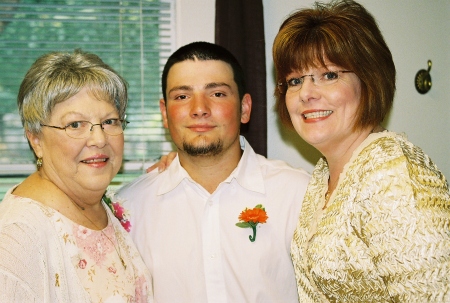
[286,64,361,153]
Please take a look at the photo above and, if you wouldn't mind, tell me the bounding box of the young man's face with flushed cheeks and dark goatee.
[160,60,251,156]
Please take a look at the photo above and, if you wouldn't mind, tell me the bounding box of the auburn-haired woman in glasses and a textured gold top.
[273,1,450,303]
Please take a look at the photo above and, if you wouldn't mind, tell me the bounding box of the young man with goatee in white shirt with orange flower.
[118,42,309,303]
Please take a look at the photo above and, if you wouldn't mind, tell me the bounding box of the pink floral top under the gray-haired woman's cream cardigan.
[54,203,147,302]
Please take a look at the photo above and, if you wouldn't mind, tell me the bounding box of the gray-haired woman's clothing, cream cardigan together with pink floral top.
[0,191,153,302]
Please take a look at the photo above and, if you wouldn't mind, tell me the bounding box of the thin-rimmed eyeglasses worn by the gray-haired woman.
[41,119,130,139]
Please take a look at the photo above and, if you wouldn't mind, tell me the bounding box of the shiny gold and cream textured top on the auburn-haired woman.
[291,132,450,303]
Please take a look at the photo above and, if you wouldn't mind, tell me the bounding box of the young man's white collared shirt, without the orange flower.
[118,137,310,303]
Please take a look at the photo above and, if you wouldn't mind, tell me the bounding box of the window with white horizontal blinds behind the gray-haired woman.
[0,0,175,175]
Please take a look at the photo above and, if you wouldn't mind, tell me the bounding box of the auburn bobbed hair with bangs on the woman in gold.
[272,0,396,130]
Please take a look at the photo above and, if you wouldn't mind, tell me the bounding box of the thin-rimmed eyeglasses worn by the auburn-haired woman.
[277,70,353,94]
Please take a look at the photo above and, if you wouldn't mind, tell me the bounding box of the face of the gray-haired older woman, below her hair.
[28,89,124,197]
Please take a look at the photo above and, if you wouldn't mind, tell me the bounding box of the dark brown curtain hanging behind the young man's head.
[215,0,267,157]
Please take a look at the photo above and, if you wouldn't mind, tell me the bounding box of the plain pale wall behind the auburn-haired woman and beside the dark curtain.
[177,0,450,178]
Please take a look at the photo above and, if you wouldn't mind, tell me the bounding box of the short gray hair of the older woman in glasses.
[17,49,128,134]
